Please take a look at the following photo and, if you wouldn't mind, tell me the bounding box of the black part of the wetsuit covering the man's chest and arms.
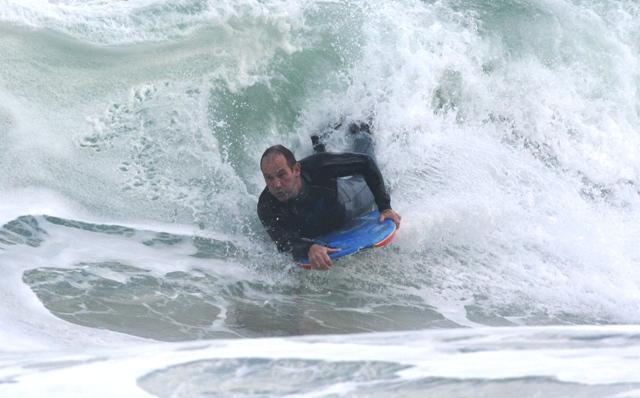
[258,152,391,260]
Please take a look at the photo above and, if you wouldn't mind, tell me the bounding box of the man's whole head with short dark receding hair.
[260,145,302,202]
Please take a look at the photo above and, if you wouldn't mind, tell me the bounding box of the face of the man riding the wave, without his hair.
[260,153,302,202]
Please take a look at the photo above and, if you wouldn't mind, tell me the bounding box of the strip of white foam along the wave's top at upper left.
[0,0,304,45]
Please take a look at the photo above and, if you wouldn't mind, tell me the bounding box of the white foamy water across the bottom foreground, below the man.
[0,326,640,397]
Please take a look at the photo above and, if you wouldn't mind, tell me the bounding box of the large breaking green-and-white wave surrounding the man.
[0,1,640,360]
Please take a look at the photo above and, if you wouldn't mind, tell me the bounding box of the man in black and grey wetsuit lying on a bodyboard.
[258,123,401,269]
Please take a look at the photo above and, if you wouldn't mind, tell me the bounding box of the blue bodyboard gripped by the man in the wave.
[298,210,396,268]
